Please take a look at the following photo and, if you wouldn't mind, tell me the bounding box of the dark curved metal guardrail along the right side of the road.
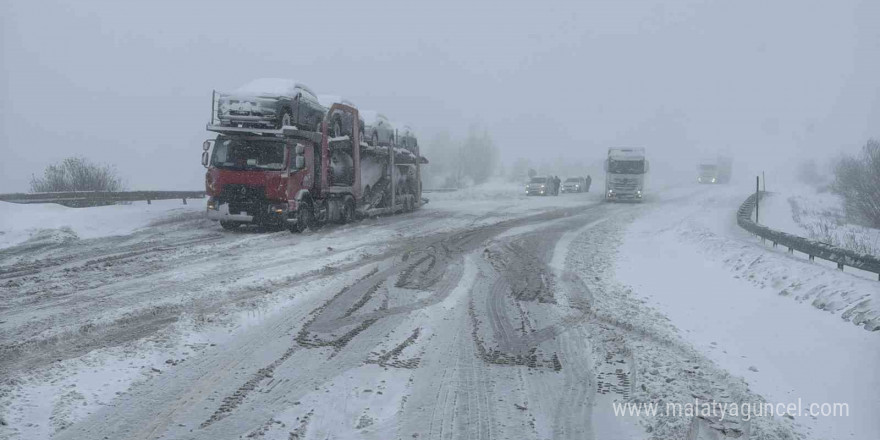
[736,191,880,279]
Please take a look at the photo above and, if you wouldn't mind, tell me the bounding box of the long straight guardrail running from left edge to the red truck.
[0,191,205,207]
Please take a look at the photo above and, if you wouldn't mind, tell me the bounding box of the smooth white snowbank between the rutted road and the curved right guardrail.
[615,186,880,438]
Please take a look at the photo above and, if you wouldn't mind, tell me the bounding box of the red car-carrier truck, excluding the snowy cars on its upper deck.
[202,103,427,232]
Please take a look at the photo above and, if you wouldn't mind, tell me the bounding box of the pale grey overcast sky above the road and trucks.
[0,0,880,193]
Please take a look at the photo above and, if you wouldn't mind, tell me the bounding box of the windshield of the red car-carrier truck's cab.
[211,137,284,171]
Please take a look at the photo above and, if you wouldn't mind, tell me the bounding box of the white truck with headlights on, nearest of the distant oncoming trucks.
[605,148,648,202]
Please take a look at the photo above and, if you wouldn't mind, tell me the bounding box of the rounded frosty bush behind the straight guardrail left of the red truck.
[31,157,122,192]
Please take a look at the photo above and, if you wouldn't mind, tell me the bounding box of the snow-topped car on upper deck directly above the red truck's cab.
[217,78,327,131]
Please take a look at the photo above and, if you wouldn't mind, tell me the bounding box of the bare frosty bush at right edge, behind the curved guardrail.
[832,139,880,228]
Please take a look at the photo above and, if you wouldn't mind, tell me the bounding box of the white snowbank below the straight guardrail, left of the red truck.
[0,200,205,249]
